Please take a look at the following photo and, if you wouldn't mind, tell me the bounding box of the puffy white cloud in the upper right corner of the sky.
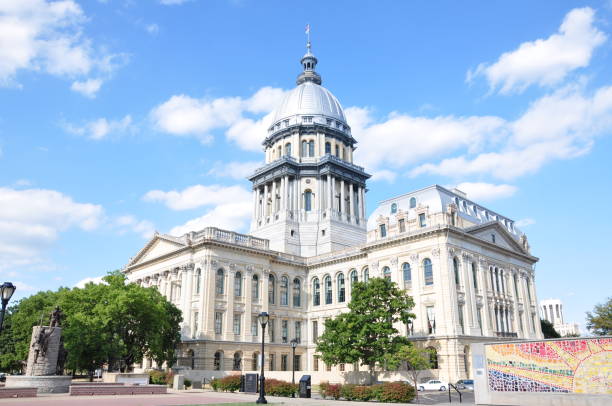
[467,7,606,93]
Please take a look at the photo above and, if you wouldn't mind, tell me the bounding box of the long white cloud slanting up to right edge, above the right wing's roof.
[410,86,612,179]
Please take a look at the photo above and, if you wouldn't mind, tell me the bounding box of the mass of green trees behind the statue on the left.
[0,271,182,376]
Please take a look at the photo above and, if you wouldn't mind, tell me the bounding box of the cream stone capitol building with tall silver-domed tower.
[124,44,542,383]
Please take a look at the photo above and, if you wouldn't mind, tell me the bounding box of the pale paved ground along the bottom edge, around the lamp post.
[0,390,474,406]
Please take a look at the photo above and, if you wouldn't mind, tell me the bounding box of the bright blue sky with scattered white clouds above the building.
[0,0,612,332]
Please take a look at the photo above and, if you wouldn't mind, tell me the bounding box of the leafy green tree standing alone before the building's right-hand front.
[317,278,415,378]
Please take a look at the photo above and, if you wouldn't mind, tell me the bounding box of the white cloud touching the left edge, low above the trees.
[0,187,103,270]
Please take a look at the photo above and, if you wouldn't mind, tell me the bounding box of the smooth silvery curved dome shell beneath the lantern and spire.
[272,82,346,125]
